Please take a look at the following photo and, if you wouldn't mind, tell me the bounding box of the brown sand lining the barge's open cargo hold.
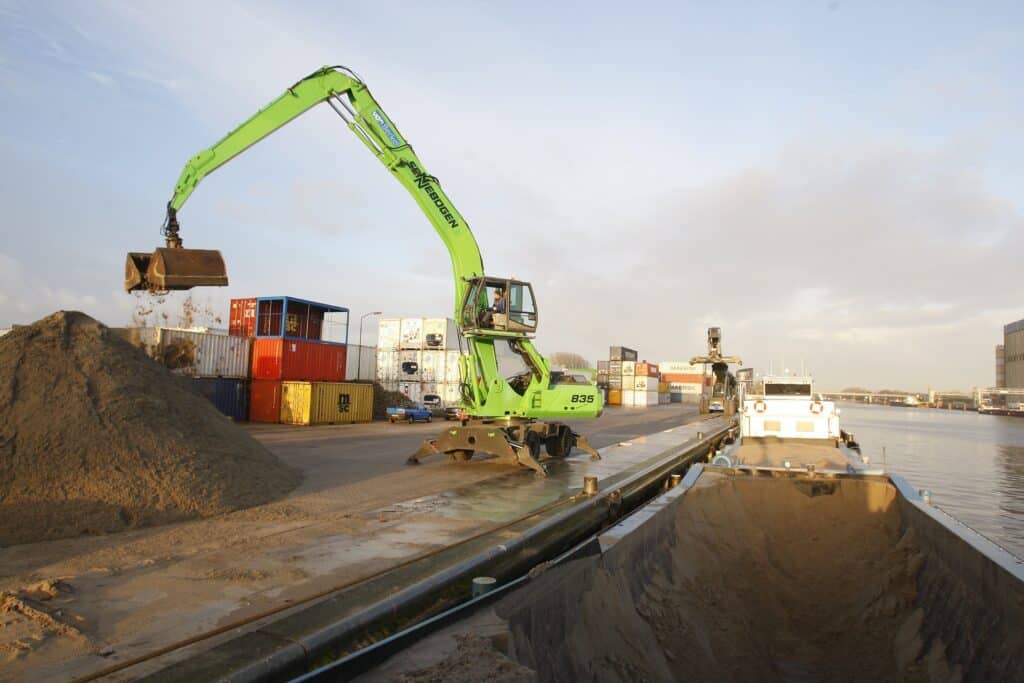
[370,474,974,682]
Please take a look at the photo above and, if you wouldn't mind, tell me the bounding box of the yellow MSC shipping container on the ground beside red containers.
[281,382,374,425]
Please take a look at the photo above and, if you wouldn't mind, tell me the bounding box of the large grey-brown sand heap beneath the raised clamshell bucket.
[0,311,300,546]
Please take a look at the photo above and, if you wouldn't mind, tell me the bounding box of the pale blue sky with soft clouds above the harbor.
[0,0,1024,390]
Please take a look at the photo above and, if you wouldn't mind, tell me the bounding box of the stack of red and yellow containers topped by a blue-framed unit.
[228,296,373,425]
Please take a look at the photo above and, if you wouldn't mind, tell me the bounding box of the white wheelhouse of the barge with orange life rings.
[740,375,840,439]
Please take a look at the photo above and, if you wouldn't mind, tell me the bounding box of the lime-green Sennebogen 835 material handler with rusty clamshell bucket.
[125,67,603,475]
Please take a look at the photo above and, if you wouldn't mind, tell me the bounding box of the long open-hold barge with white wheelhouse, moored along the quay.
[329,378,1024,681]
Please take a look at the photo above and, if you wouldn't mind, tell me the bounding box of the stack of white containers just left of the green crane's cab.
[377,317,462,408]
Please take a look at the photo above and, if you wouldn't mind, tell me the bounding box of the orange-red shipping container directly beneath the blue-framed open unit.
[252,337,347,382]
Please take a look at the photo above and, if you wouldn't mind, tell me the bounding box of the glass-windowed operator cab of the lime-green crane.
[461,278,537,337]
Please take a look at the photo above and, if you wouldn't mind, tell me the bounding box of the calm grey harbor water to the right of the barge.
[840,403,1024,558]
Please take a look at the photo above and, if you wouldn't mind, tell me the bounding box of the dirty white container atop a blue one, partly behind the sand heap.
[126,328,252,379]
